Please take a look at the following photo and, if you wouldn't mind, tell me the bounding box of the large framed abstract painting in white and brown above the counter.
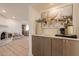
[41,5,73,28]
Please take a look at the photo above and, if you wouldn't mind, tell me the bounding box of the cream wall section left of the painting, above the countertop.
[29,6,40,34]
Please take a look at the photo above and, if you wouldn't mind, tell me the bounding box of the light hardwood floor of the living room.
[0,37,29,56]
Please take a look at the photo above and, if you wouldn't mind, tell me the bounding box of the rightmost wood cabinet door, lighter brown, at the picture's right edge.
[63,40,79,56]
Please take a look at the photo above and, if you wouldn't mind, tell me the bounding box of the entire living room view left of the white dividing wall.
[0,3,29,56]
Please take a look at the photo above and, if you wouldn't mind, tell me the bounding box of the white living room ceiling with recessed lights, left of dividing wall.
[0,3,28,20]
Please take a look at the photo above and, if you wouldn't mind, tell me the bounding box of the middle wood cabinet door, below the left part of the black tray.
[52,38,63,56]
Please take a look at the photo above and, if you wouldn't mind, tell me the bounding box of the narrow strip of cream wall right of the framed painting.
[73,4,79,38]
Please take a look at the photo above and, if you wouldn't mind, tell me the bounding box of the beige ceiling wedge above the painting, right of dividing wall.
[33,3,64,11]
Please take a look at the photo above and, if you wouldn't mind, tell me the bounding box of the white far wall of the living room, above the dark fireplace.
[0,17,27,34]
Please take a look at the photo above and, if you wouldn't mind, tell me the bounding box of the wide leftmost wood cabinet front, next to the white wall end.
[32,36,51,56]
